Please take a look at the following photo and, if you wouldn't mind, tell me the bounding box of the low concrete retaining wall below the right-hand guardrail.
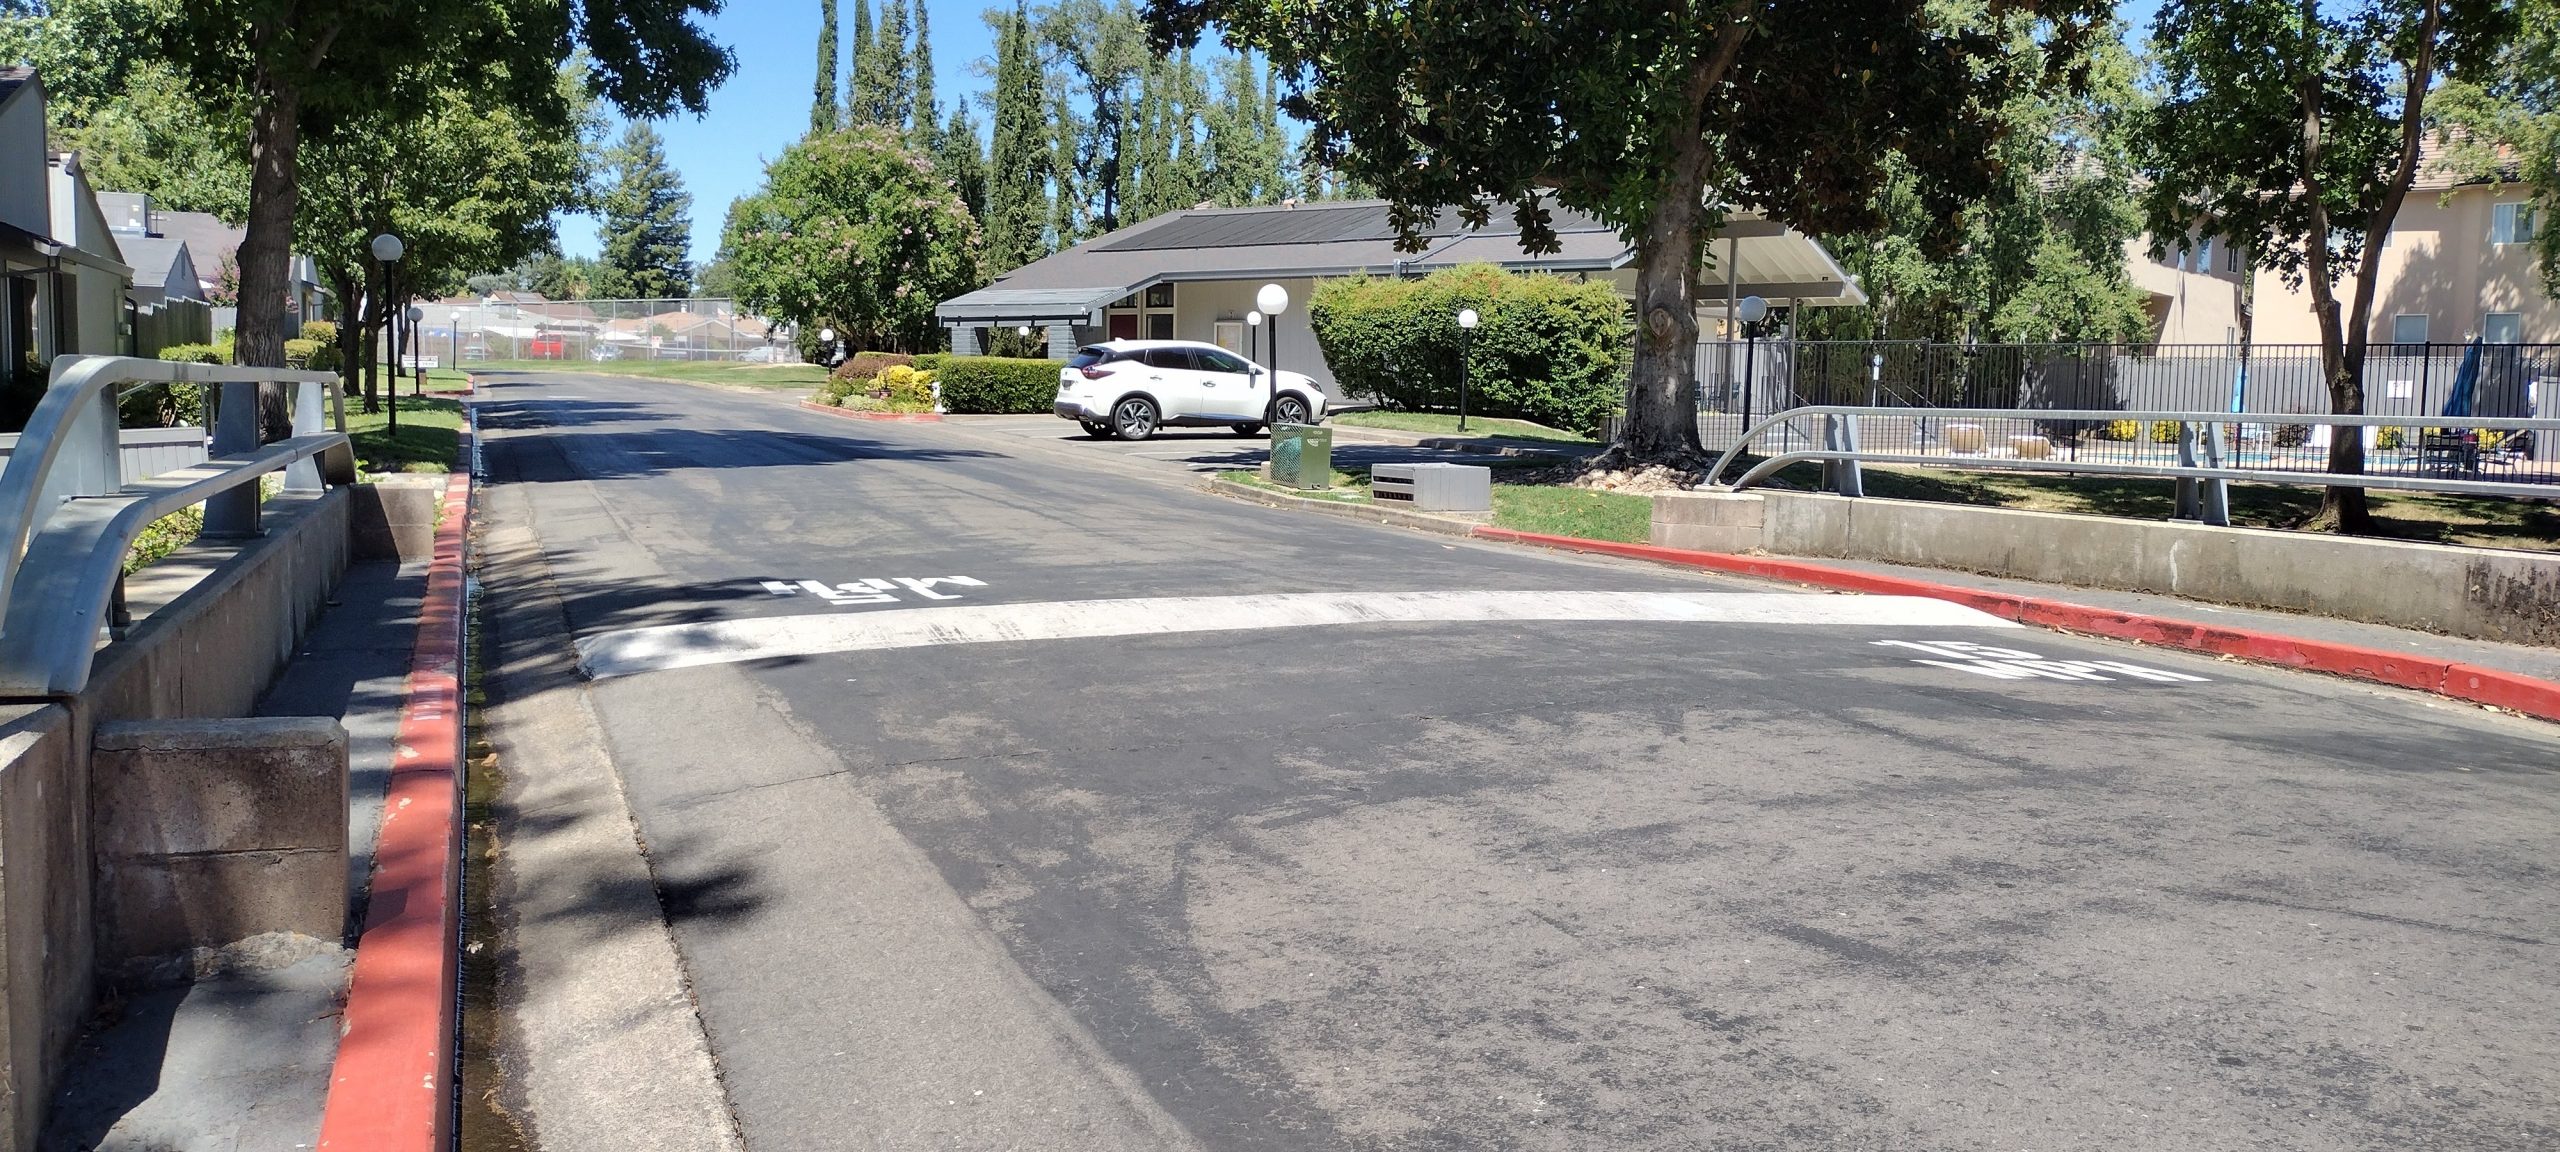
[1654,492,2560,645]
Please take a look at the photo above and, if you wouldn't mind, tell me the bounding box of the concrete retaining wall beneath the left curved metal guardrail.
[0,489,353,1152]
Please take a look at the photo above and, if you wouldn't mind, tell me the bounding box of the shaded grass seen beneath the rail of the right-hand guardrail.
[1779,463,2560,550]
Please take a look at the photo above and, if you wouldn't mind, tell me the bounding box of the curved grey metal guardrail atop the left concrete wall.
[0,356,356,696]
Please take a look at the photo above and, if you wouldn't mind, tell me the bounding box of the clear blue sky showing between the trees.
[561,0,2161,264]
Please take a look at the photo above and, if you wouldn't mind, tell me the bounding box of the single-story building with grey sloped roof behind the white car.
[934,200,1866,384]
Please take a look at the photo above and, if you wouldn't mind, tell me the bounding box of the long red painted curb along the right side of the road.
[1475,525,2560,722]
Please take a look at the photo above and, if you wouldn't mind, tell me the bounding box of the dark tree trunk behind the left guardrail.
[233,51,302,440]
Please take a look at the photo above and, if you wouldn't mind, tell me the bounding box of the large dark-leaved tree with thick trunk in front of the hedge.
[1149,0,2112,463]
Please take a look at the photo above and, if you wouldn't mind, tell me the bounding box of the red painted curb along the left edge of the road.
[320,474,471,1152]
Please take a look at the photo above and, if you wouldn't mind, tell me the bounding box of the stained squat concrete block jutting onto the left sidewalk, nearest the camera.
[90,717,348,968]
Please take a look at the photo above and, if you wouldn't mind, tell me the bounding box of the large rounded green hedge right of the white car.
[1308,264,1636,433]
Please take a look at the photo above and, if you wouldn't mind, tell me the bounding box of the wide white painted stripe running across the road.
[579,591,2022,678]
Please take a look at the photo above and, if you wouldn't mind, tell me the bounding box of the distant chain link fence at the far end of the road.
[417,292,799,366]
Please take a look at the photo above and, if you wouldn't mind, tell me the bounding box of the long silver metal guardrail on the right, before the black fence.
[1708,404,2560,525]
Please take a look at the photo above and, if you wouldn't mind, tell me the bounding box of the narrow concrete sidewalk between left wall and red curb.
[41,561,428,1152]
